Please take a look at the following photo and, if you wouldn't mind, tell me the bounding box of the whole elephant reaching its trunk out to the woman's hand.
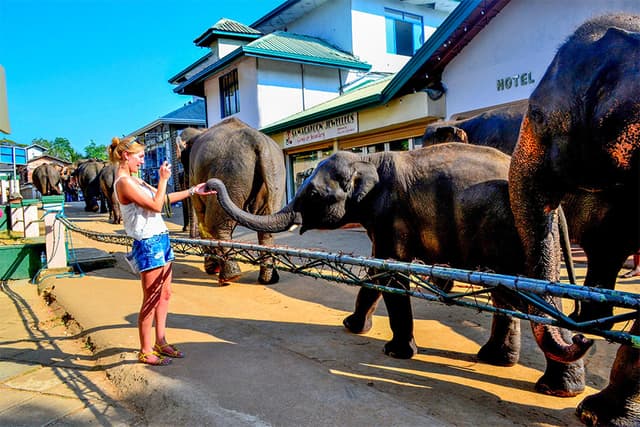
[207,143,590,396]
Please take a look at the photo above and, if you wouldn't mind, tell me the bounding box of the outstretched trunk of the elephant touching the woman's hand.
[207,178,300,233]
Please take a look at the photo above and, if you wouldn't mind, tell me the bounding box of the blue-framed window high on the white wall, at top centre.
[384,8,424,56]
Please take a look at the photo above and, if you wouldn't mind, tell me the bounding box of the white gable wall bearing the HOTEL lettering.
[443,0,640,117]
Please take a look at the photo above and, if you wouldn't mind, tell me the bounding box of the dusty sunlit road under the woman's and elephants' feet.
[6,201,640,426]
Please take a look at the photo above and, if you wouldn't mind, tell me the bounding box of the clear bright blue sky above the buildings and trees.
[0,0,284,154]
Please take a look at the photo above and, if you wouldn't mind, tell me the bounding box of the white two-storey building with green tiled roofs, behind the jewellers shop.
[169,0,458,128]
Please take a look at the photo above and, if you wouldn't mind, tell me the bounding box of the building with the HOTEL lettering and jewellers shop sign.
[260,0,640,197]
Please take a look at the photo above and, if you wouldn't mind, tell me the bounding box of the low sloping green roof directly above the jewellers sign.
[260,75,393,134]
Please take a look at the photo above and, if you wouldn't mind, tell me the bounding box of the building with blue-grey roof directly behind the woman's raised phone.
[130,99,206,191]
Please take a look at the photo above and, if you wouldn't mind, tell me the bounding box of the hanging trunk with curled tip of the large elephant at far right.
[509,115,593,363]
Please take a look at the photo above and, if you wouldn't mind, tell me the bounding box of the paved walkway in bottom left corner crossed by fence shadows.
[0,280,144,427]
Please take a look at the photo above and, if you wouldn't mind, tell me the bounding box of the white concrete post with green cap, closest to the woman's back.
[42,196,67,269]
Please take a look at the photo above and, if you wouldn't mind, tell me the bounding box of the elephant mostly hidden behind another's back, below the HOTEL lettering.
[422,102,527,155]
